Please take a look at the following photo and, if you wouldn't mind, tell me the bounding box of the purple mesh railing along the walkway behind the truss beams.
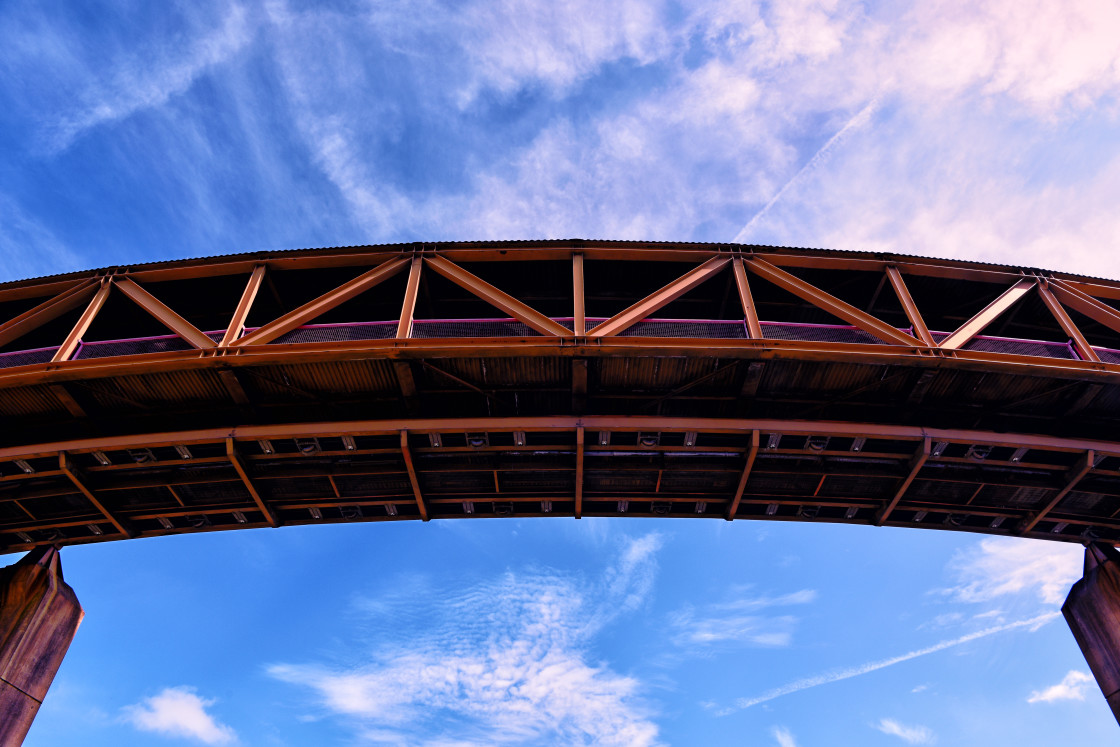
[0,317,1106,368]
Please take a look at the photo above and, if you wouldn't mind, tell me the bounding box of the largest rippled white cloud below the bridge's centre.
[269,535,660,746]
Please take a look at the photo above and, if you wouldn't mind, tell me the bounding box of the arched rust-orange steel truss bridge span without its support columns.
[0,241,1120,552]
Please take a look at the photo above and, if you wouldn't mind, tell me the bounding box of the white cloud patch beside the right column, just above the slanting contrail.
[945,538,1084,605]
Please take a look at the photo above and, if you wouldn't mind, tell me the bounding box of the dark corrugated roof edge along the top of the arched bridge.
[0,239,1120,290]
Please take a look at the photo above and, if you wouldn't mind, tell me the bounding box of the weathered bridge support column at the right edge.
[1062,543,1120,722]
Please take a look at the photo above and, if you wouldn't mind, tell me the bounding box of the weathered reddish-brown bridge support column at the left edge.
[0,548,84,747]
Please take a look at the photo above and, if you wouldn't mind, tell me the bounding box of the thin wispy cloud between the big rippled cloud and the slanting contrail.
[670,589,816,648]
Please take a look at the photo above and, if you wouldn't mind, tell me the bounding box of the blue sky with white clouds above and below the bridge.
[0,0,1120,747]
